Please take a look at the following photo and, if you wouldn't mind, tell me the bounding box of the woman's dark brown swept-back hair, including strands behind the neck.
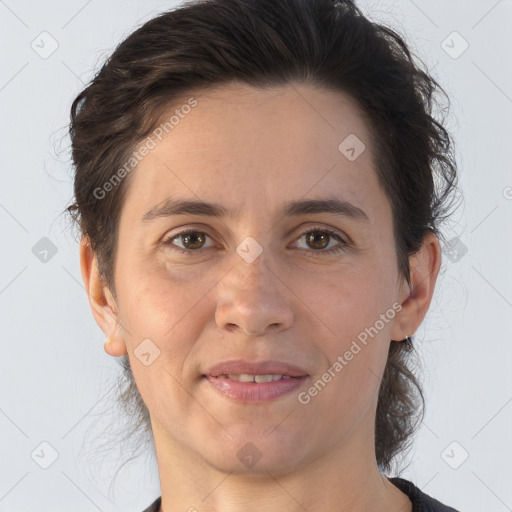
[67,0,457,471]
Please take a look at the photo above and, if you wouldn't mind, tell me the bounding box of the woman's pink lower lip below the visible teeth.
[205,375,307,402]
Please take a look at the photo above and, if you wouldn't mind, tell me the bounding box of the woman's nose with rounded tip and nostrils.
[215,251,293,336]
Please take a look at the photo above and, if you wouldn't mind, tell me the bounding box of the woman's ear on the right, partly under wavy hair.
[391,232,441,340]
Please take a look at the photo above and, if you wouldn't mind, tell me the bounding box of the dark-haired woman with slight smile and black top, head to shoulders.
[69,0,456,512]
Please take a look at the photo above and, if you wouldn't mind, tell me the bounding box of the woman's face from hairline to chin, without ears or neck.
[92,85,420,474]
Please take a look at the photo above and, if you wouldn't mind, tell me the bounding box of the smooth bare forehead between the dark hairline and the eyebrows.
[127,84,381,222]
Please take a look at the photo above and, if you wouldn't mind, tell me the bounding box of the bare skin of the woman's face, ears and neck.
[80,84,440,512]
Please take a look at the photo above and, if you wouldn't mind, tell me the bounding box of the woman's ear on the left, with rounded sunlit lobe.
[80,236,127,357]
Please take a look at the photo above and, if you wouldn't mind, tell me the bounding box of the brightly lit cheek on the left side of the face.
[118,269,213,415]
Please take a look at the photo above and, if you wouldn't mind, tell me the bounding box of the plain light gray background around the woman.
[0,0,512,512]
